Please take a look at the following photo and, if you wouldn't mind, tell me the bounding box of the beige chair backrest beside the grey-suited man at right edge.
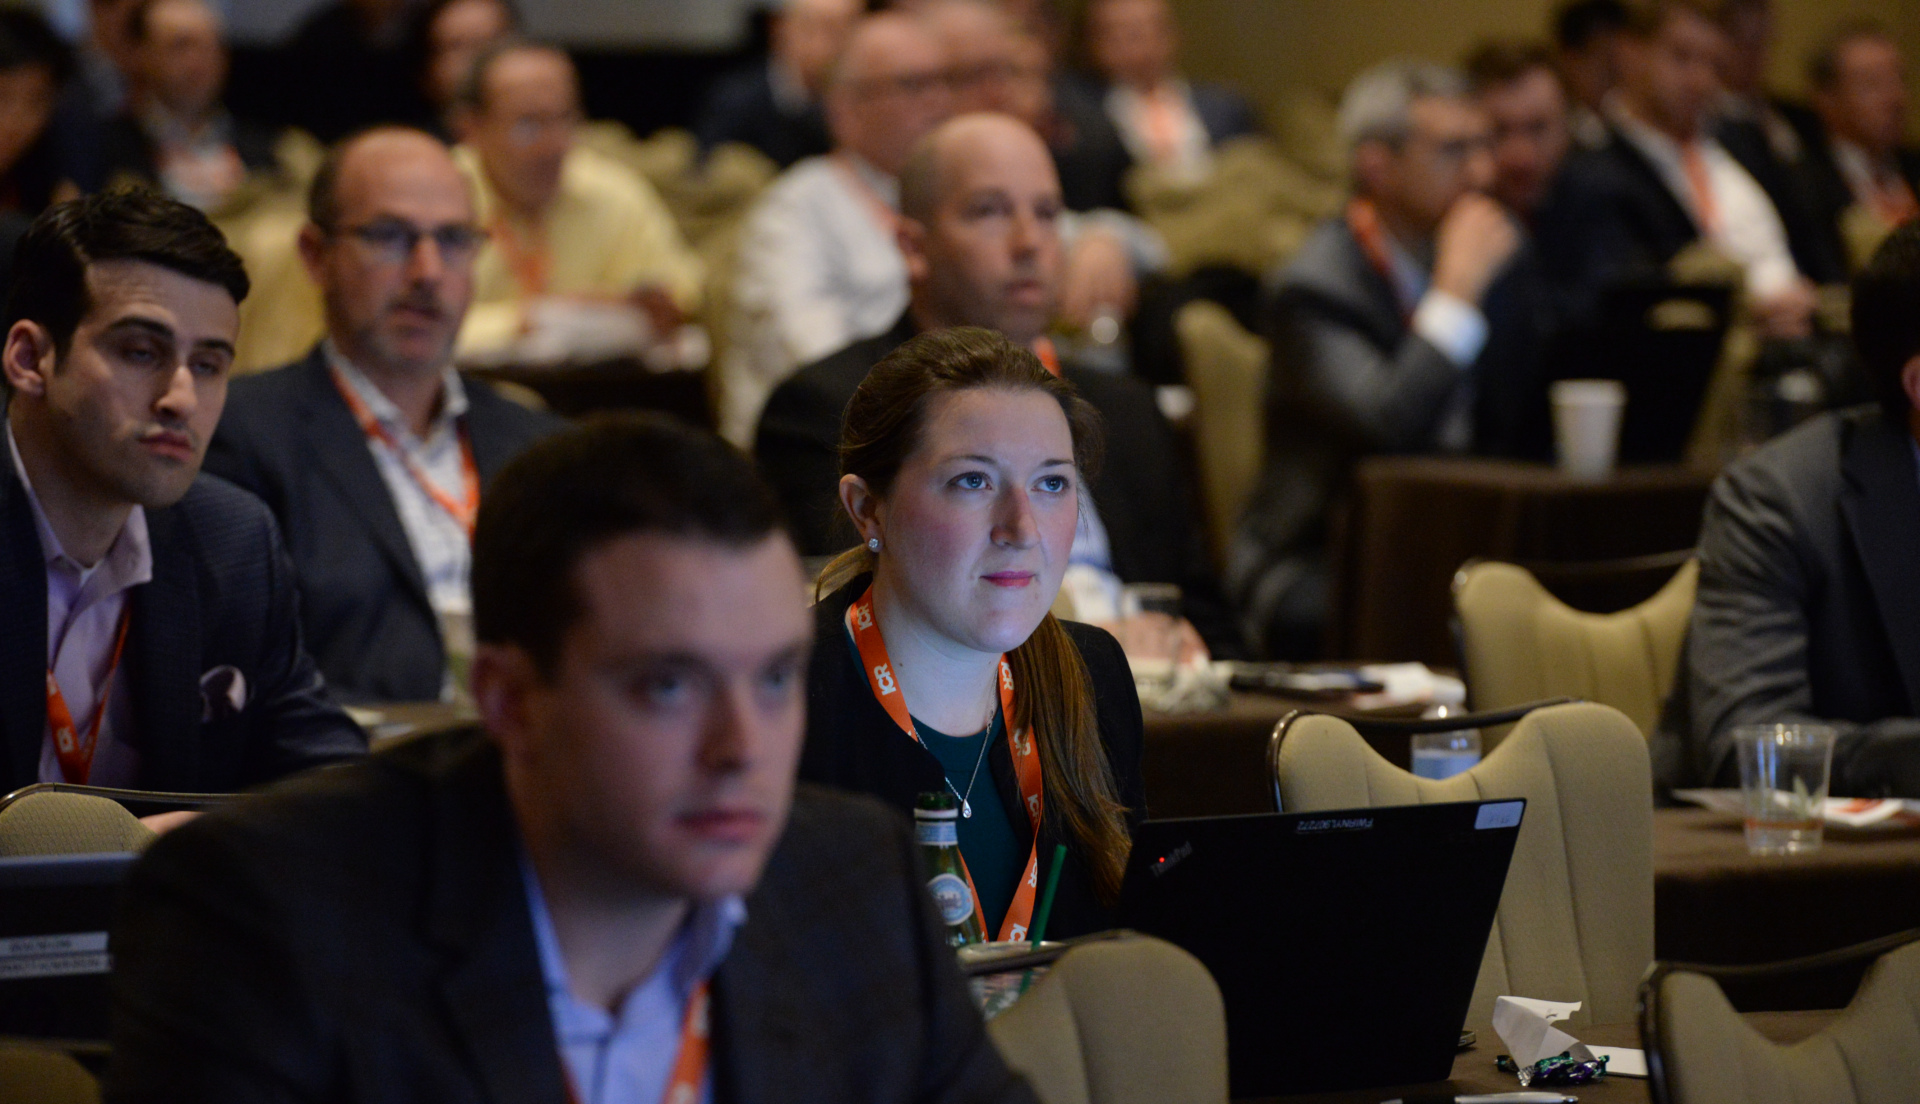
[1453,561,1699,735]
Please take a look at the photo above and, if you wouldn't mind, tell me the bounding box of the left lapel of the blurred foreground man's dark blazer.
[426,737,566,1104]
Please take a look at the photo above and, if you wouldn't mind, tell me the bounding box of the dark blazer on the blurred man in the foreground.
[106,730,1033,1104]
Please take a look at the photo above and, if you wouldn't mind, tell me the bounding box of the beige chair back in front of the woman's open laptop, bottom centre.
[987,935,1227,1104]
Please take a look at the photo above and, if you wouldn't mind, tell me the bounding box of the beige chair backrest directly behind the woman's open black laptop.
[1275,703,1653,1023]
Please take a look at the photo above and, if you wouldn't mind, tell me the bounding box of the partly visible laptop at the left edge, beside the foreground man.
[0,852,138,1041]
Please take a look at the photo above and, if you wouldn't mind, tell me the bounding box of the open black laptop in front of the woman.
[1119,799,1526,1098]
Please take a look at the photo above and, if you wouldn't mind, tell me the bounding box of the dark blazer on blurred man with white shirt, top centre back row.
[1050,73,1260,211]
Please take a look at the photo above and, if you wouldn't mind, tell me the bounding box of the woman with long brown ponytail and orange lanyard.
[801,328,1144,939]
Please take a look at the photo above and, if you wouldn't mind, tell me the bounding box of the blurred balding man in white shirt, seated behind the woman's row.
[720,12,952,445]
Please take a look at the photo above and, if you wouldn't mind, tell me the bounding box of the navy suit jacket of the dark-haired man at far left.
[0,461,367,793]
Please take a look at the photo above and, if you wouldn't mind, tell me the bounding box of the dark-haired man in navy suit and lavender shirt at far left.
[0,192,367,791]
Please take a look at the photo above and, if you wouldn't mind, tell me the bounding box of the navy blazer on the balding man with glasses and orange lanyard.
[207,348,564,701]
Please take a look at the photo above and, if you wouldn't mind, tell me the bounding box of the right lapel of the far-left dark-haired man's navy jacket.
[127,509,202,791]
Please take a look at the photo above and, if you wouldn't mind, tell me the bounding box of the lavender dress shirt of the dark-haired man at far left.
[6,426,154,787]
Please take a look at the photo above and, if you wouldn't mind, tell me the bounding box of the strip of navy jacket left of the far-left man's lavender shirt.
[0,462,46,791]
